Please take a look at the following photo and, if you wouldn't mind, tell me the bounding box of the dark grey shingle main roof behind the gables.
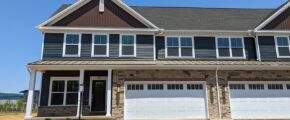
[53,4,275,30]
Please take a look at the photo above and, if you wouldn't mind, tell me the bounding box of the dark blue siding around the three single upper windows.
[43,33,154,60]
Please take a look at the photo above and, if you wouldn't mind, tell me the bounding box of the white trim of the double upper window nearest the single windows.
[165,35,195,59]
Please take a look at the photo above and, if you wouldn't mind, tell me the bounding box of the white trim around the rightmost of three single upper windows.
[119,34,137,57]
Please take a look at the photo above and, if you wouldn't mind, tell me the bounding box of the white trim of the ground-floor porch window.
[48,77,80,106]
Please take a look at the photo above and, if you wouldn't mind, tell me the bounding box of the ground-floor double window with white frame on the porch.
[49,78,79,106]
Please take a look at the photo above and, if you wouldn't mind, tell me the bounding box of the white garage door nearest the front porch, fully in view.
[125,82,208,120]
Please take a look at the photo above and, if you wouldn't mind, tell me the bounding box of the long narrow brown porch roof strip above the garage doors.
[29,60,290,66]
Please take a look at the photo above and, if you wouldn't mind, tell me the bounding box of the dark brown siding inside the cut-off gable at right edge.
[263,8,290,30]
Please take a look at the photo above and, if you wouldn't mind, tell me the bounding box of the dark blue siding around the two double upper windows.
[156,36,257,60]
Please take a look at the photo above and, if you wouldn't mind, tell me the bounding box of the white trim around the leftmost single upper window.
[62,33,82,57]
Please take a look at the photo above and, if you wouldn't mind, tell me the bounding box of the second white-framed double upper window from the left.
[216,37,245,59]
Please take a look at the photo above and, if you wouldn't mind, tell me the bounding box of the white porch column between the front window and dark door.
[77,70,85,117]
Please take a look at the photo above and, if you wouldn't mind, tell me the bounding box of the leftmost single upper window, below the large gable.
[63,34,81,57]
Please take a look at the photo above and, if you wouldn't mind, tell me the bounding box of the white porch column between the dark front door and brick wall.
[106,69,112,116]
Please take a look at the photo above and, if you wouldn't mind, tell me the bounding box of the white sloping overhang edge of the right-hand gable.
[254,0,290,32]
